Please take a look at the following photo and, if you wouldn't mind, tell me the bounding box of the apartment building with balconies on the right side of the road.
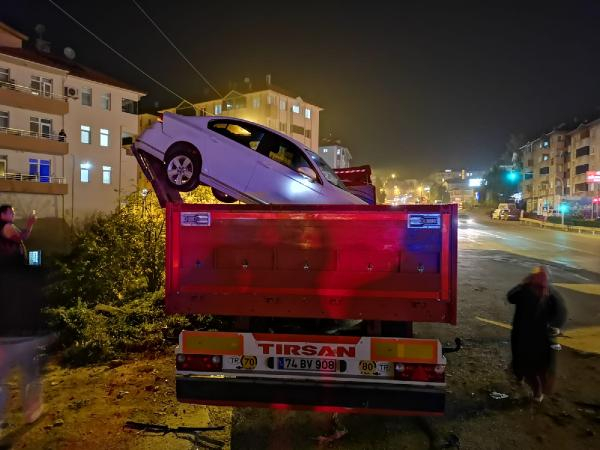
[521,119,600,215]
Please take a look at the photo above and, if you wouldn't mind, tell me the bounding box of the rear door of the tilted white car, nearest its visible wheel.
[202,119,263,192]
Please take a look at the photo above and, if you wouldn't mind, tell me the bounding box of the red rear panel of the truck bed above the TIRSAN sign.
[166,203,457,324]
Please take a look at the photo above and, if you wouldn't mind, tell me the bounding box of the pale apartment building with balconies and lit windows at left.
[0,23,144,241]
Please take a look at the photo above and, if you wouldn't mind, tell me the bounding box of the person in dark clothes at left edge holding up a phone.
[0,205,45,423]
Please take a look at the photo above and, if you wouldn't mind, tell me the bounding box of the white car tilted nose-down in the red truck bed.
[135,113,366,205]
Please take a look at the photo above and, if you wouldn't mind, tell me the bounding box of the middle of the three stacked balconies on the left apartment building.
[0,127,69,155]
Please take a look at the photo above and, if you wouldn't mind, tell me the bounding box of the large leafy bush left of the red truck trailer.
[46,190,220,365]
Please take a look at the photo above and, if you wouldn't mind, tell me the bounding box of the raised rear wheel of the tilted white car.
[165,145,201,192]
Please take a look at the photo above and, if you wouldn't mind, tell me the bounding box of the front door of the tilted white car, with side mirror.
[247,130,324,204]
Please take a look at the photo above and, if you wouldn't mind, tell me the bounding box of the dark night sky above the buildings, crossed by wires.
[0,0,600,178]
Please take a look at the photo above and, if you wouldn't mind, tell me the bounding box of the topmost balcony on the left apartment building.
[0,81,69,115]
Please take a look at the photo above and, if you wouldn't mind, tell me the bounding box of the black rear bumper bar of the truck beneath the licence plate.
[176,376,445,415]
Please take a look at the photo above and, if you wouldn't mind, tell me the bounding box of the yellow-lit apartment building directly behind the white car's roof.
[161,75,323,152]
